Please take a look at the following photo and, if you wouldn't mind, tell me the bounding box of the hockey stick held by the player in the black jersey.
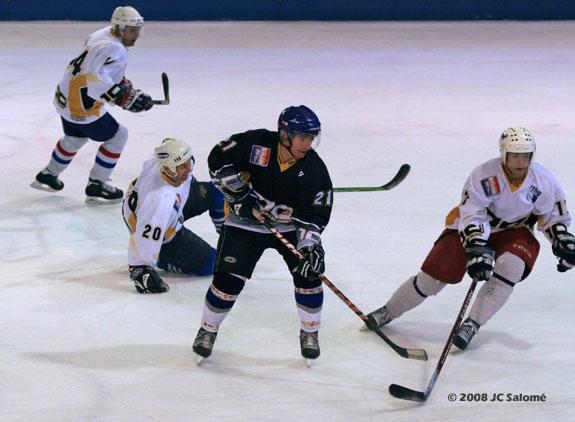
[256,214,427,360]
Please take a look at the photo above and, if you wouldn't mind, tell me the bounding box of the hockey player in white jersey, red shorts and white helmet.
[368,127,575,349]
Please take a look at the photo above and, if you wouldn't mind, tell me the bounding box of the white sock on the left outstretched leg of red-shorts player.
[386,271,445,318]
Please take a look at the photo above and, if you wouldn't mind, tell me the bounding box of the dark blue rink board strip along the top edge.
[0,0,575,20]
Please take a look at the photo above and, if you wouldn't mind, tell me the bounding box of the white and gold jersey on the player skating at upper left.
[54,26,128,124]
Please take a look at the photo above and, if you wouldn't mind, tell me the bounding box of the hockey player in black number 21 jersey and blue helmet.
[193,105,333,359]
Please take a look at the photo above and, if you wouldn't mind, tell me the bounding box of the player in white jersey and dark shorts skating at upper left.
[31,6,153,203]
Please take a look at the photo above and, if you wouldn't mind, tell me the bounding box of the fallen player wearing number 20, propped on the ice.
[122,138,224,293]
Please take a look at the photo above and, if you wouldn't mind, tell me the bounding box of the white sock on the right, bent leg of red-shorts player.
[469,252,525,326]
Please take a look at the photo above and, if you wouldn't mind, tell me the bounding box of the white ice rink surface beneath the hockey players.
[0,22,575,422]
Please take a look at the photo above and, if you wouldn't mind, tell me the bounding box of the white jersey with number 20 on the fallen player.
[122,158,192,268]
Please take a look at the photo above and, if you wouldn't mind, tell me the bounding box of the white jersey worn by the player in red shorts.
[446,158,571,239]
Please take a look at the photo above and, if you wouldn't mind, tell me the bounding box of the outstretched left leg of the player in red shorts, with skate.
[367,230,466,327]
